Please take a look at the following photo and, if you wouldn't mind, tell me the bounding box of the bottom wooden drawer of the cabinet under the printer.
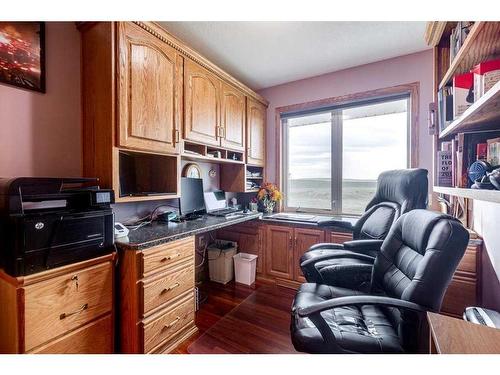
[30,314,113,354]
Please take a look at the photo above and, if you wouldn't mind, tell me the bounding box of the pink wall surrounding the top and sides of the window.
[259,50,432,185]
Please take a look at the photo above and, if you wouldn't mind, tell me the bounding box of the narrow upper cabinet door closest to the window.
[247,98,266,166]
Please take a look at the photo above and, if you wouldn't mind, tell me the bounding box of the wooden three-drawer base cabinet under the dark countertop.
[119,237,197,353]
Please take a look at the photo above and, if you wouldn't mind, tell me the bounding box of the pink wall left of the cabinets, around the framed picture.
[0,22,81,177]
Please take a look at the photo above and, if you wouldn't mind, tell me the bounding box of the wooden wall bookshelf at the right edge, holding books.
[425,21,500,203]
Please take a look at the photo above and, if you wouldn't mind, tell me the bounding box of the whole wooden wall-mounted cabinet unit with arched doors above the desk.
[78,22,266,202]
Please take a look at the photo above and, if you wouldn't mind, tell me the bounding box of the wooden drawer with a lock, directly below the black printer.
[23,263,113,351]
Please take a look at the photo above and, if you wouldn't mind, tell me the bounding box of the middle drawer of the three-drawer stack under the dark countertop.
[141,262,194,316]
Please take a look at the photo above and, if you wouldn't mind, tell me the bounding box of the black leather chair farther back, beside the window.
[300,169,428,287]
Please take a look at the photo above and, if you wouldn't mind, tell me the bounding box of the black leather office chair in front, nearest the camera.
[291,210,469,353]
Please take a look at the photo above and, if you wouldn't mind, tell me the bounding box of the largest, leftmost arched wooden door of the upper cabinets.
[118,22,183,153]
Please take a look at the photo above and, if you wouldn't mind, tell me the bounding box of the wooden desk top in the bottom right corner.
[427,313,500,354]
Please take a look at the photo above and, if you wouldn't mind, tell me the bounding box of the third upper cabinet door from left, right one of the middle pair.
[220,83,245,151]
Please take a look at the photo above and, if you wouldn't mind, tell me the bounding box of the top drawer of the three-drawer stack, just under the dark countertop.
[143,237,194,277]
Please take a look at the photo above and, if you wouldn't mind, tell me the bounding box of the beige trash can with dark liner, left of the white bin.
[207,240,238,284]
